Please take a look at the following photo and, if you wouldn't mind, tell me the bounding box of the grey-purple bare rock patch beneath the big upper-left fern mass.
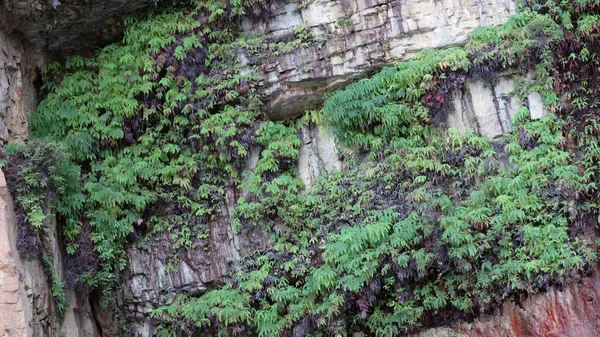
[124,213,268,336]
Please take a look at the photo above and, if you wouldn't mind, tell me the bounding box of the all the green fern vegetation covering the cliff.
[7,0,600,336]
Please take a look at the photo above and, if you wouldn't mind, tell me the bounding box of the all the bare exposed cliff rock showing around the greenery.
[0,0,600,337]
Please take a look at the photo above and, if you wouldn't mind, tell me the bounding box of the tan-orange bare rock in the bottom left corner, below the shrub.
[0,166,101,337]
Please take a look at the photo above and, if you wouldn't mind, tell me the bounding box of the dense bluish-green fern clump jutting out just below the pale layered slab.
[324,48,470,150]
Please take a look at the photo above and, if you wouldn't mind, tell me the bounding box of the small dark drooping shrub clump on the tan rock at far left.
[4,140,79,320]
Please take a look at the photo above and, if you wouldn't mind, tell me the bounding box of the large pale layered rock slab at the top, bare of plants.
[251,0,515,119]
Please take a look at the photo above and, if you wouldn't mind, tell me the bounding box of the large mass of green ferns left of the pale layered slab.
[31,1,280,278]
